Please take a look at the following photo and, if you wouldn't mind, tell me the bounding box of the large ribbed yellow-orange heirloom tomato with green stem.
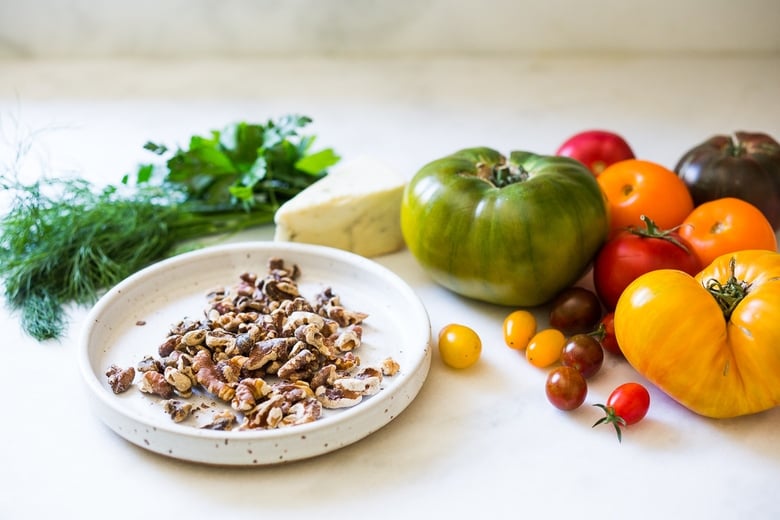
[615,250,780,418]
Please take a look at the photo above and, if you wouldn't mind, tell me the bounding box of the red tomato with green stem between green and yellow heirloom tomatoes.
[593,215,702,310]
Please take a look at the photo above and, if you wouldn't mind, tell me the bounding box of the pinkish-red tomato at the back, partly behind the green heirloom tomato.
[555,130,634,176]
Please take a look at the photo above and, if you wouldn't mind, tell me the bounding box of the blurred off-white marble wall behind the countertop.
[0,0,780,59]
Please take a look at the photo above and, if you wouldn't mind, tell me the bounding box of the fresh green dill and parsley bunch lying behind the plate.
[0,116,339,340]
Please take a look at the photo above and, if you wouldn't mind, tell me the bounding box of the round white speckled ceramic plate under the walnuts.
[79,242,431,465]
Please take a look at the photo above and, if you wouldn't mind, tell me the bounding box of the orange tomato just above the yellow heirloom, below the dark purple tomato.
[679,197,777,267]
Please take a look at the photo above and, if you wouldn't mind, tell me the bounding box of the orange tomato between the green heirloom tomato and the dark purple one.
[596,159,693,235]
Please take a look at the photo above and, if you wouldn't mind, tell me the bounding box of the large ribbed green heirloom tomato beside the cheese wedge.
[401,148,609,307]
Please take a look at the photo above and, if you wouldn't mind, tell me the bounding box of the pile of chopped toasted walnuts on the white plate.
[106,258,400,430]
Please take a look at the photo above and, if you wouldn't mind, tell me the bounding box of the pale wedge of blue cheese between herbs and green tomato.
[274,156,406,257]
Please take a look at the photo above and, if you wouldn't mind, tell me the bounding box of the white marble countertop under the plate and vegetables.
[0,54,780,519]
